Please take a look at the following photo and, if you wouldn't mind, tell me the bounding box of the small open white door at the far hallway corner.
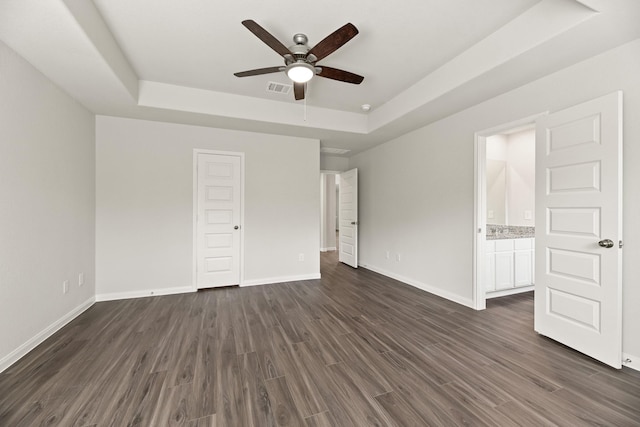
[338,169,358,268]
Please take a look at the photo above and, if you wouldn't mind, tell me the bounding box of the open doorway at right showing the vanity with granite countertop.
[474,115,541,310]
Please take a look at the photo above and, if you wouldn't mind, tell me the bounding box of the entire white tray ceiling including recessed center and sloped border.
[0,0,640,154]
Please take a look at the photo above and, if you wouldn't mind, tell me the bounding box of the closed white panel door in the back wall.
[196,153,242,289]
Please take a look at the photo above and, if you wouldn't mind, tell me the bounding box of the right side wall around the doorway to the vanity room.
[349,40,640,362]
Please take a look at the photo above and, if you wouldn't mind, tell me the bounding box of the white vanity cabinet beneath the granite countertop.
[485,238,534,292]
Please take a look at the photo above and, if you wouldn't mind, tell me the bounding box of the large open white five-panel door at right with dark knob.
[535,92,622,368]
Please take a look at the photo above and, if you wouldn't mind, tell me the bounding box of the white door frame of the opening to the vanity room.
[472,111,549,310]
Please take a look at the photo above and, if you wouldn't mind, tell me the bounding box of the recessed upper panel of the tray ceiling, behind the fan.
[94,0,536,112]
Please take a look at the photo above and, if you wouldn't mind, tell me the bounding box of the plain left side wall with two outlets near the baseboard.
[0,42,95,371]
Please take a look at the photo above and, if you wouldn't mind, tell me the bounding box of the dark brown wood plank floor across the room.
[0,253,640,427]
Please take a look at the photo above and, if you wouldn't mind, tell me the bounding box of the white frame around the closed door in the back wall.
[191,148,245,292]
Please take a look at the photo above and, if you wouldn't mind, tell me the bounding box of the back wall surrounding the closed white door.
[96,116,320,299]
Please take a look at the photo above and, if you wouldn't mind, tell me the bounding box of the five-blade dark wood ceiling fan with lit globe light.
[234,19,364,100]
